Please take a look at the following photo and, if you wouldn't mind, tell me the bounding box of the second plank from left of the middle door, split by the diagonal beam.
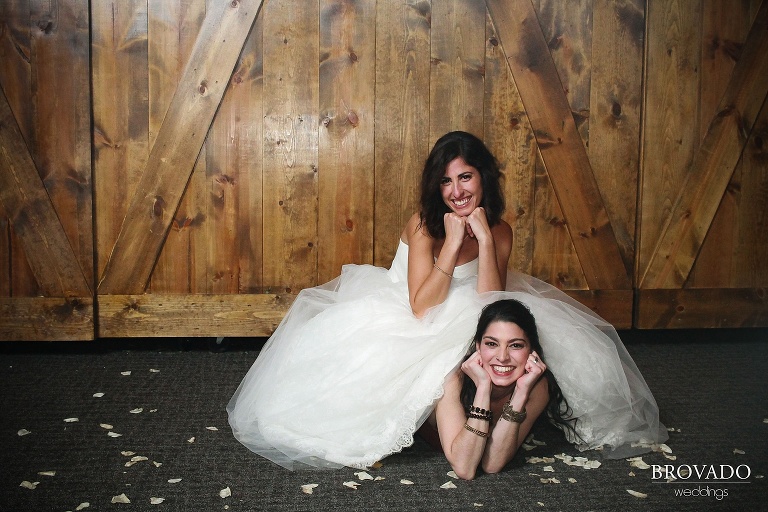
[147,0,205,293]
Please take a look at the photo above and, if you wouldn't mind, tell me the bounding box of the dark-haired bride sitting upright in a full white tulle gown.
[227,132,666,469]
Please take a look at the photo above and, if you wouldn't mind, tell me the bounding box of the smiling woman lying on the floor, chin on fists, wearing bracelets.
[420,299,575,480]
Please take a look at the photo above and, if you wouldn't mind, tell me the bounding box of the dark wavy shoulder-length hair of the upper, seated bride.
[419,131,505,238]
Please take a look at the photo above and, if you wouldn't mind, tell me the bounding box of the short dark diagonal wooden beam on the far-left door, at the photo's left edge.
[0,85,93,297]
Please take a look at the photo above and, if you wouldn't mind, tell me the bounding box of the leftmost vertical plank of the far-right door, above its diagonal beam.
[636,0,702,283]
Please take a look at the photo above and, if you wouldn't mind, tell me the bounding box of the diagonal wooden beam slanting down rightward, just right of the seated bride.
[486,0,631,289]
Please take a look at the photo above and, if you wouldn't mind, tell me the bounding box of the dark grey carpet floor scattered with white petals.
[0,329,768,512]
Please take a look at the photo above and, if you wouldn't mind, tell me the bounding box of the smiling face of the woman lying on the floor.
[477,321,531,387]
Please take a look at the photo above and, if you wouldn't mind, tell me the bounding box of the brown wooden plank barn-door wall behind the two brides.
[0,0,768,339]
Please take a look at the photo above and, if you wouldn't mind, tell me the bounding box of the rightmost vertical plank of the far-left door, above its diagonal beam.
[30,0,94,288]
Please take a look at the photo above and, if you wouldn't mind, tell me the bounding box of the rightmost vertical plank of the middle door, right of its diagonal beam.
[589,0,645,275]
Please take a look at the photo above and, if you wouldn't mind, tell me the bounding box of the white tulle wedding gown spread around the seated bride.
[227,241,667,469]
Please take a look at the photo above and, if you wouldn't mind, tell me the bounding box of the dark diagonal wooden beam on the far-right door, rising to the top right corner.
[639,1,768,289]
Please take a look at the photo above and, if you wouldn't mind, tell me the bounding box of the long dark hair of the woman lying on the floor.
[461,299,580,439]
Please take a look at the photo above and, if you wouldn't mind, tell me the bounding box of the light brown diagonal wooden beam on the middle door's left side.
[98,0,262,295]
